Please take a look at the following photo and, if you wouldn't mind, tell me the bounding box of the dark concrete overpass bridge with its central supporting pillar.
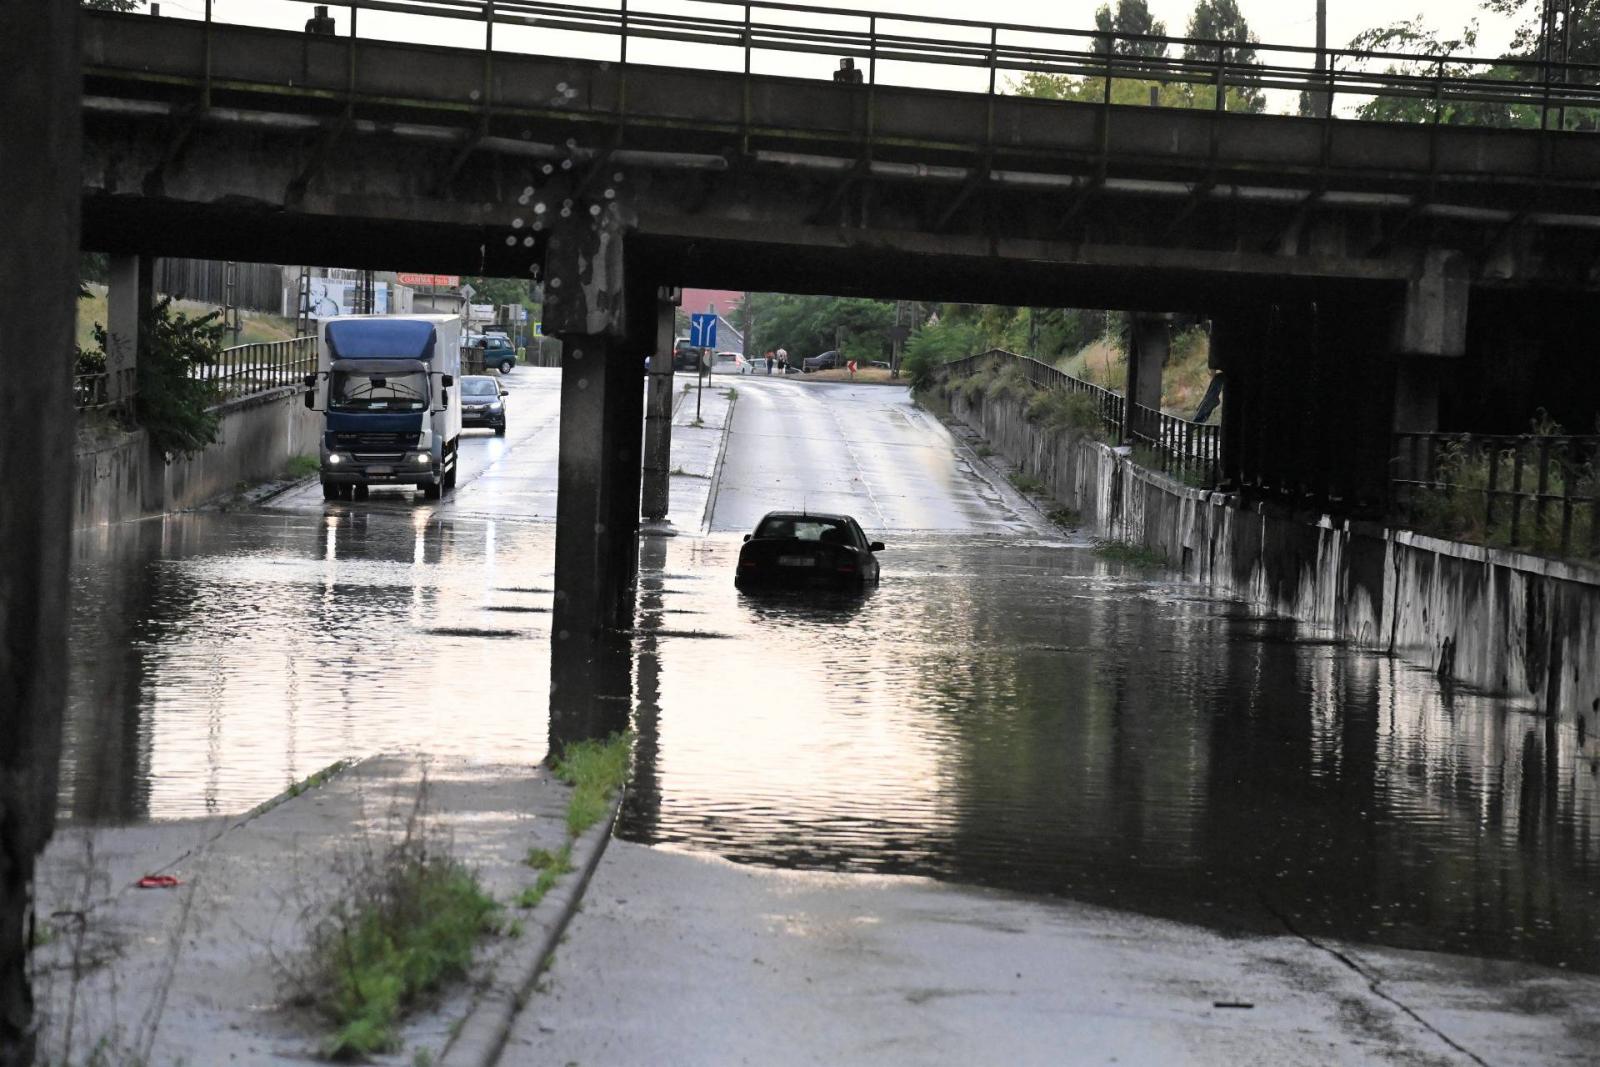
[82,0,1600,643]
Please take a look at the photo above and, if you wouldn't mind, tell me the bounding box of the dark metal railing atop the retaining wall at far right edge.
[1389,434,1600,558]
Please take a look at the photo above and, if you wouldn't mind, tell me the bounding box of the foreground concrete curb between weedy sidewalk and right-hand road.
[437,789,626,1067]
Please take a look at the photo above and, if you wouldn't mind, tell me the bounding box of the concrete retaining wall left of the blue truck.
[72,389,322,528]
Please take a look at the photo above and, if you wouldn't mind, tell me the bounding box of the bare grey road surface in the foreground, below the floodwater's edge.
[499,841,1600,1067]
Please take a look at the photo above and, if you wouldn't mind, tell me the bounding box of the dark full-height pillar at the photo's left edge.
[0,3,83,1064]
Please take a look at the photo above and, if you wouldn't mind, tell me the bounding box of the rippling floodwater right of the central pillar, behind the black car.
[608,537,1600,969]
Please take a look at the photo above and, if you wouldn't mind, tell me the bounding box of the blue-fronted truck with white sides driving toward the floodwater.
[306,315,461,501]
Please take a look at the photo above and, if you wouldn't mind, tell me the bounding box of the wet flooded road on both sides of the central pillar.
[62,370,1600,971]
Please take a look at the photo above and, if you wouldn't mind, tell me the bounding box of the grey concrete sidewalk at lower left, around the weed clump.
[35,757,571,1067]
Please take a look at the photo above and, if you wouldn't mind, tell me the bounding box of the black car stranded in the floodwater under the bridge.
[733,512,883,589]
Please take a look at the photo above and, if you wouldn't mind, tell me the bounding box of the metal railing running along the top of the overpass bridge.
[134,0,1600,132]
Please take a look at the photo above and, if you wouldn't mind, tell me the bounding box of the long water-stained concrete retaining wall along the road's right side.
[941,379,1600,726]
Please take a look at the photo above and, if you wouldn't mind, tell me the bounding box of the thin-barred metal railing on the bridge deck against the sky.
[150,0,1600,138]
